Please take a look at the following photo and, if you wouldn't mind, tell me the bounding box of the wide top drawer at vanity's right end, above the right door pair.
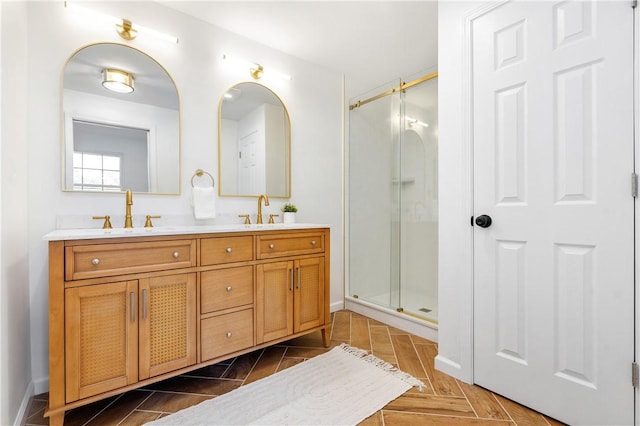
[258,232,324,259]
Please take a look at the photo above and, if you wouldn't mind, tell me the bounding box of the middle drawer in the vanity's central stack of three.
[200,266,253,314]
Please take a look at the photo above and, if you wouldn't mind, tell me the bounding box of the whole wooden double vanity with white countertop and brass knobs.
[45,224,330,425]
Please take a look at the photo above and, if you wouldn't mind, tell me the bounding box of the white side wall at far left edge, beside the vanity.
[0,2,32,425]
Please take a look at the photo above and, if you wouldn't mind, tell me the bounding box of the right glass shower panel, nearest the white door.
[398,78,438,322]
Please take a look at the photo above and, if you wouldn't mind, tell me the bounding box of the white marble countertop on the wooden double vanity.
[43,223,330,241]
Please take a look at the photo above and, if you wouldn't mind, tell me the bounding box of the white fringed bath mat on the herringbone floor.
[147,344,424,425]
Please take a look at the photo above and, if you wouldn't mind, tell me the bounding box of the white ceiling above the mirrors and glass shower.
[160,0,438,94]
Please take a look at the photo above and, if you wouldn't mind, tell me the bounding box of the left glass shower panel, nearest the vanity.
[349,81,401,309]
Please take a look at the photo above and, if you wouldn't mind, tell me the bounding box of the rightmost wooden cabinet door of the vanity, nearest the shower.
[293,257,325,333]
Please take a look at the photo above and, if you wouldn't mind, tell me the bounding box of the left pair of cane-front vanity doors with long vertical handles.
[64,273,196,403]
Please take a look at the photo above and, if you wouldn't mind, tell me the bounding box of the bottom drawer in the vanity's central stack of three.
[200,309,254,361]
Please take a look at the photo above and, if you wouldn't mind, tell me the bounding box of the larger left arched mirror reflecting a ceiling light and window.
[62,43,180,194]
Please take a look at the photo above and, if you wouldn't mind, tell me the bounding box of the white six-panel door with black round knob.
[470,1,634,425]
